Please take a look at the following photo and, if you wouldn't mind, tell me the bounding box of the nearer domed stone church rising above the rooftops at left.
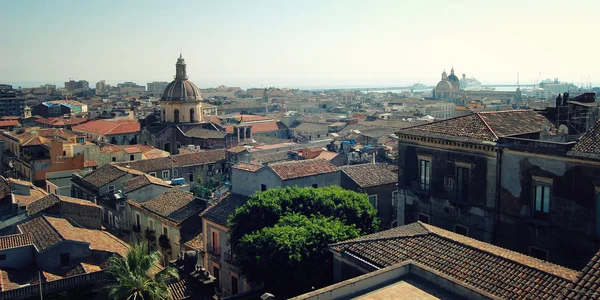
[139,54,252,154]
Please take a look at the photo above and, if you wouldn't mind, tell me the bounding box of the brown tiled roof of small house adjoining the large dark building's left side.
[340,164,398,188]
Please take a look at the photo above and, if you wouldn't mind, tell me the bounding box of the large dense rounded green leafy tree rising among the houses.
[229,186,379,297]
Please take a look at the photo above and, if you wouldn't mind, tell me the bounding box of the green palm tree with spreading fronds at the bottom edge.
[106,244,179,300]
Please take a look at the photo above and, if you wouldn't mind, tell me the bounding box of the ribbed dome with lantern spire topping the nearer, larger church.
[160,55,202,101]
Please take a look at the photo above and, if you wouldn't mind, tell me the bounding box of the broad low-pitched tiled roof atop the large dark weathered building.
[399,110,554,142]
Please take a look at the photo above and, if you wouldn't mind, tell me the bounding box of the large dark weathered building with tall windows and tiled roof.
[397,111,600,268]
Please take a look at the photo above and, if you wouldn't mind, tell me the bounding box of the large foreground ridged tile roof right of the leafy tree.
[330,222,577,299]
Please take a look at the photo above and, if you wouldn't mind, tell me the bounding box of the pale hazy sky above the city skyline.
[0,0,600,87]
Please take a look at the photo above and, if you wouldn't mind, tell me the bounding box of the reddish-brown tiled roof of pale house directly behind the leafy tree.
[268,158,339,180]
